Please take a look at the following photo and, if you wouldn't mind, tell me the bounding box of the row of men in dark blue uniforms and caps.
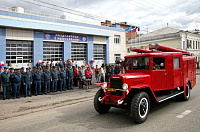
[0,65,74,100]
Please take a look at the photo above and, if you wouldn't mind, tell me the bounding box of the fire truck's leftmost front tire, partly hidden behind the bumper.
[94,89,110,114]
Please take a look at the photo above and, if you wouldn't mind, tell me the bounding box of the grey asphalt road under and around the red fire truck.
[0,75,200,132]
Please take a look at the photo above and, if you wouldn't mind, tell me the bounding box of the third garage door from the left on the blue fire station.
[71,43,87,61]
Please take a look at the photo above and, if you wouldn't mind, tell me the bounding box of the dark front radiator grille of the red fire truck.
[110,78,123,96]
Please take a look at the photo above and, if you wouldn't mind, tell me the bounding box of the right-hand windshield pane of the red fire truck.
[133,57,149,70]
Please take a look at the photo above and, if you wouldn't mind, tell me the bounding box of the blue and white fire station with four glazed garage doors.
[0,7,126,67]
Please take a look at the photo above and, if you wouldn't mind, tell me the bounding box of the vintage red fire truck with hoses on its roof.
[94,44,196,123]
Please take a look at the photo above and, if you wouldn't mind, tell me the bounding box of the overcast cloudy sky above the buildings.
[0,0,200,33]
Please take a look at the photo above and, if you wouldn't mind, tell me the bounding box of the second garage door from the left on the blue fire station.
[43,42,63,61]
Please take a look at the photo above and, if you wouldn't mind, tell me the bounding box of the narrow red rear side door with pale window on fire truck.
[173,56,183,88]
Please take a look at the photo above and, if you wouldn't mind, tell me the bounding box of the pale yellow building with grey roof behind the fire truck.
[127,27,200,63]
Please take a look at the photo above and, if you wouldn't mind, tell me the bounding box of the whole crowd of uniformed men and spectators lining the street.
[0,63,120,100]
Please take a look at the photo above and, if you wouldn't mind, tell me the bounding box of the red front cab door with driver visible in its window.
[151,57,167,91]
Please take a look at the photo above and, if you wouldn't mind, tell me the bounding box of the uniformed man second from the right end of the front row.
[59,66,66,91]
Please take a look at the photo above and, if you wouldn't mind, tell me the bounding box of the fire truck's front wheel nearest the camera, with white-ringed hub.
[131,92,150,124]
